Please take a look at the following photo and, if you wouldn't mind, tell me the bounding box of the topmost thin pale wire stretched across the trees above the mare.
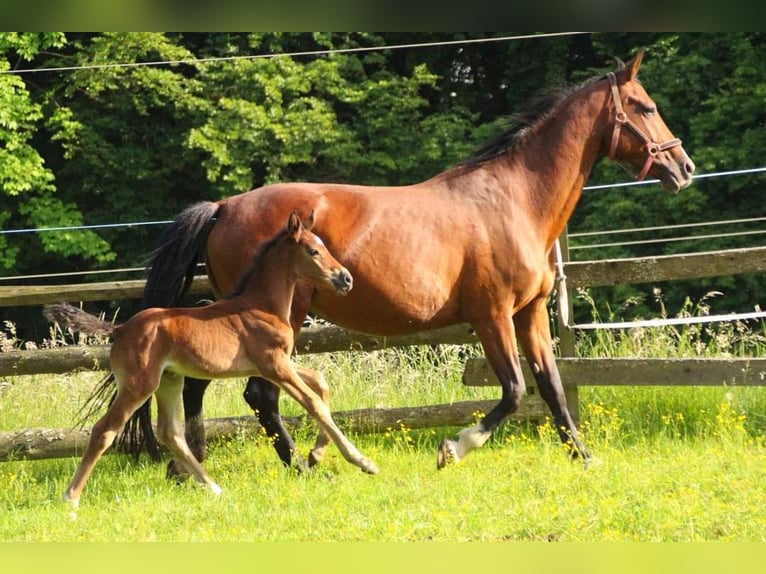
[0,32,590,74]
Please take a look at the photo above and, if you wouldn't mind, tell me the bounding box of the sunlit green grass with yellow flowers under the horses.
[0,304,766,541]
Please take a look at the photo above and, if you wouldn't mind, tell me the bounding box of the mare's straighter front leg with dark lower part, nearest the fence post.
[514,298,590,460]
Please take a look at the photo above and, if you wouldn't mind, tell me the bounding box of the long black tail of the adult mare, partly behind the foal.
[115,201,219,461]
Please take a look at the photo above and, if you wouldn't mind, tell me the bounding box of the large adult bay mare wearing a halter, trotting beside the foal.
[132,48,694,467]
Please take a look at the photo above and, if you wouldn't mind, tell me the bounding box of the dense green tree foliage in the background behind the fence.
[0,33,766,340]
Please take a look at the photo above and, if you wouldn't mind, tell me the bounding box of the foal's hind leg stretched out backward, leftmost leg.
[64,381,151,508]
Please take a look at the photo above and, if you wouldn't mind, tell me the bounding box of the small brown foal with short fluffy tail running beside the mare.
[45,213,378,506]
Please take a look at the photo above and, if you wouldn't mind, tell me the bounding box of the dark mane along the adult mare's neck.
[457,72,612,170]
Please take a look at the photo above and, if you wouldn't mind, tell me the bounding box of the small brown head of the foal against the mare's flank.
[287,211,354,295]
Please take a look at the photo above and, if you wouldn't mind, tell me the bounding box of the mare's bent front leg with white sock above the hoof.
[436,311,526,468]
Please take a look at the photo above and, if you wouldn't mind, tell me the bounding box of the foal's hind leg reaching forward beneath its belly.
[154,373,221,494]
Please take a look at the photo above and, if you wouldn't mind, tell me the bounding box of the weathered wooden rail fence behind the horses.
[0,243,766,460]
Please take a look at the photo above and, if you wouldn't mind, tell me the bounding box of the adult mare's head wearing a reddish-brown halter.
[606,50,694,193]
